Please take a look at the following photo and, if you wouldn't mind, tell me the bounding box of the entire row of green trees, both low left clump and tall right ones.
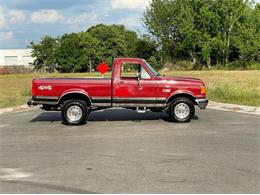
[30,0,260,72]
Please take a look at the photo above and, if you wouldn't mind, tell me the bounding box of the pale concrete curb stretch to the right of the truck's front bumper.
[207,101,260,115]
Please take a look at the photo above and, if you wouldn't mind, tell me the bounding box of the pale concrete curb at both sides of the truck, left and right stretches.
[0,101,260,115]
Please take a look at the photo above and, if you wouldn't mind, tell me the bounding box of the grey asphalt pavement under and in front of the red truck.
[0,109,260,193]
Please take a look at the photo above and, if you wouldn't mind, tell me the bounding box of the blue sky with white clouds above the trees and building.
[0,0,149,49]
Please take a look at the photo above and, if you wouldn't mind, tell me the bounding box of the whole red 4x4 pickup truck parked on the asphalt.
[28,58,208,125]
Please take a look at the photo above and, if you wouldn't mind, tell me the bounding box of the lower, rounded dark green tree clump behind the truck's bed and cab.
[30,24,159,72]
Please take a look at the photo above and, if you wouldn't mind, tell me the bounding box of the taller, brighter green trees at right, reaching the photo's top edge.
[144,0,260,68]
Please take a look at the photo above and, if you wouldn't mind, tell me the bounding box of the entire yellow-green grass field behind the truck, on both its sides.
[0,70,260,108]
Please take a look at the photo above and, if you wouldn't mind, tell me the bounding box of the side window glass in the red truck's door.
[121,63,151,79]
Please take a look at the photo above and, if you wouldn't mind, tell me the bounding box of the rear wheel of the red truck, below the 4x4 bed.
[62,100,88,126]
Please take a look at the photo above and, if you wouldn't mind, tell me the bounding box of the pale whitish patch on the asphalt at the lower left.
[0,168,31,180]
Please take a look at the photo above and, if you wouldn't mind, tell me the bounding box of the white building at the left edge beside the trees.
[0,49,34,67]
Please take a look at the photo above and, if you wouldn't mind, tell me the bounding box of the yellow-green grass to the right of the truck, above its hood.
[166,70,260,106]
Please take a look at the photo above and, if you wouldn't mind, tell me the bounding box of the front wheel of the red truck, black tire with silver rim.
[167,97,195,123]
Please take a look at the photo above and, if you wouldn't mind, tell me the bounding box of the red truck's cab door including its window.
[113,62,157,107]
